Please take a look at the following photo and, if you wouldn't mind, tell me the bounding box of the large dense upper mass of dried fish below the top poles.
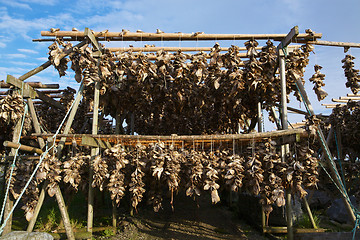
[49,40,313,134]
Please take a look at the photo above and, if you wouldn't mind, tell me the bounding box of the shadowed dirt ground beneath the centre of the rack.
[100,194,267,240]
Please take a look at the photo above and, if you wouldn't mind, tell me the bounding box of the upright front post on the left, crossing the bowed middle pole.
[87,78,100,234]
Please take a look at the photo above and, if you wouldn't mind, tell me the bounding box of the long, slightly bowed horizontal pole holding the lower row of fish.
[16,128,310,152]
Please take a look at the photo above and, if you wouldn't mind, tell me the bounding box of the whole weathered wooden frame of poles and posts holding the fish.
[0,26,360,239]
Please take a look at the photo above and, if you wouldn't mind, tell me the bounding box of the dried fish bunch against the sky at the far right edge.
[341,54,360,94]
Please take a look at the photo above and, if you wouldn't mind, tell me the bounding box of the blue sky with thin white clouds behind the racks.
[0,0,360,129]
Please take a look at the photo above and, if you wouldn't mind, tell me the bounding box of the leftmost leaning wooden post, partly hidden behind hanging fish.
[3,119,22,236]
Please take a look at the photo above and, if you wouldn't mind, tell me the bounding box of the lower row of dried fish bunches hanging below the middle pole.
[7,139,318,222]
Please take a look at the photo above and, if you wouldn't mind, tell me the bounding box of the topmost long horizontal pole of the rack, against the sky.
[41,31,322,41]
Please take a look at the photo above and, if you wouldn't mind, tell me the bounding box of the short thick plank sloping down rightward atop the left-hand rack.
[6,75,65,109]
